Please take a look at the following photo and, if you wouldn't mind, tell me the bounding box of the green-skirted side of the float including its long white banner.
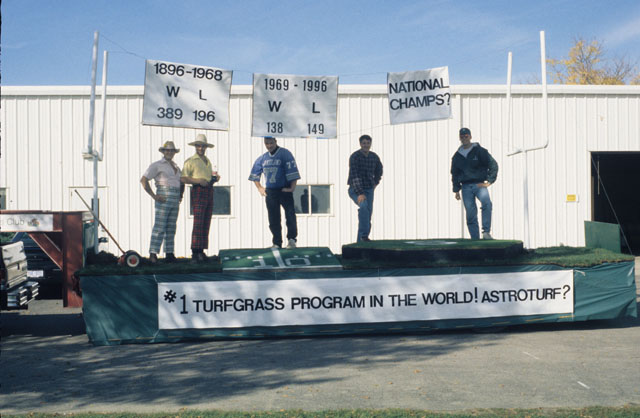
[80,261,637,345]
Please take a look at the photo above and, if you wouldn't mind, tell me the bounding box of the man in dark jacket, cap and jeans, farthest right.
[451,128,498,239]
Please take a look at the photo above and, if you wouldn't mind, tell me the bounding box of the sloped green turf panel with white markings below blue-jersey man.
[219,247,342,271]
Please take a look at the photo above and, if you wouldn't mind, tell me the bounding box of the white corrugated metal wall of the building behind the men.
[0,86,640,255]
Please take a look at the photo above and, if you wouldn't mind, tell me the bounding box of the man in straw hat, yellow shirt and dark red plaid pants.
[181,134,220,262]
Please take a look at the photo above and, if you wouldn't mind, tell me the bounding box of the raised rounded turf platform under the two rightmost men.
[342,238,524,263]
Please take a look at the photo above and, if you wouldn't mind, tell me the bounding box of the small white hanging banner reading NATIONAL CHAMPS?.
[387,67,451,125]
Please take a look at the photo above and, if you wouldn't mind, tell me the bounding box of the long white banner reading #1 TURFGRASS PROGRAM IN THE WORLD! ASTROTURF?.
[158,270,573,329]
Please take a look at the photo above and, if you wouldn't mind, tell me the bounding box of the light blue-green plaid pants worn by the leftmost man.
[149,186,180,254]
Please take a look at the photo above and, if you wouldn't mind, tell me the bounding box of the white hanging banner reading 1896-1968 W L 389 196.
[142,60,233,130]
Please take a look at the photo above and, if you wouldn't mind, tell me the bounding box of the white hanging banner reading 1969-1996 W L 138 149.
[252,74,338,138]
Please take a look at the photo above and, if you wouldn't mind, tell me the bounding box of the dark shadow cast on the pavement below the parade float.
[0,298,640,412]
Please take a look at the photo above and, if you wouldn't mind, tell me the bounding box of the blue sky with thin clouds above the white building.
[0,0,640,85]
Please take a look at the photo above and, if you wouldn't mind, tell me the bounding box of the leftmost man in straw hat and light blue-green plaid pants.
[140,141,184,264]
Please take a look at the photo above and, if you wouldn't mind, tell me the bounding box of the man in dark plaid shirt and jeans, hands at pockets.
[347,135,382,242]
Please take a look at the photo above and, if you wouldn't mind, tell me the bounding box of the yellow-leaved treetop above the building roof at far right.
[547,37,640,84]
